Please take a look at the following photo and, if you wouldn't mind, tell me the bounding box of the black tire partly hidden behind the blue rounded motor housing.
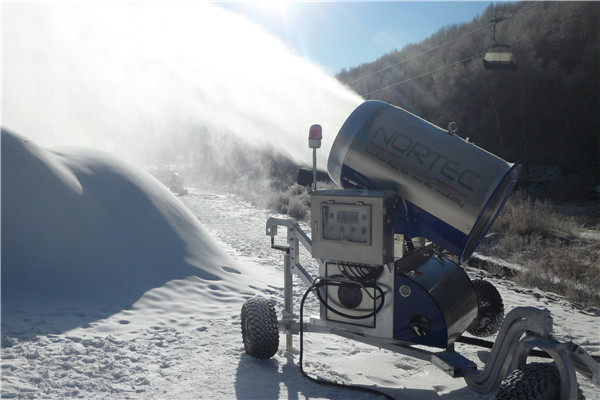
[467,279,504,337]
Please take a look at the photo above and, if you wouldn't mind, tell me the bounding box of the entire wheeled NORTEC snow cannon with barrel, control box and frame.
[241,101,600,399]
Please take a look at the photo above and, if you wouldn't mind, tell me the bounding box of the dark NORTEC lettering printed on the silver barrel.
[372,125,482,192]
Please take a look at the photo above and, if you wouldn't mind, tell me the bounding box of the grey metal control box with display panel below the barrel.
[311,190,395,265]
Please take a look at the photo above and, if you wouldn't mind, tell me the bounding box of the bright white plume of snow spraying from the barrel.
[2,2,361,178]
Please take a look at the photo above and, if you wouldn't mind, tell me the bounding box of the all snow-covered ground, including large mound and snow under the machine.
[1,133,600,399]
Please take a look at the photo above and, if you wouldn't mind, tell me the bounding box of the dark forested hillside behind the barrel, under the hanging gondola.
[337,1,600,200]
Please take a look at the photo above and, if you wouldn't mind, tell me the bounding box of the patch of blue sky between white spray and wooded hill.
[218,1,494,74]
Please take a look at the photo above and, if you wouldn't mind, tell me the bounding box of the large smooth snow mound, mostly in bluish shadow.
[2,129,258,331]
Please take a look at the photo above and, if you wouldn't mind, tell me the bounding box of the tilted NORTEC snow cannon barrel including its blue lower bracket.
[327,100,521,262]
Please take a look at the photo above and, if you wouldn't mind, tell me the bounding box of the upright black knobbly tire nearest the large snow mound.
[241,296,279,359]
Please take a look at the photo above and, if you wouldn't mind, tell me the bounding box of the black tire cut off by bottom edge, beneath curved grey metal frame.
[496,363,585,400]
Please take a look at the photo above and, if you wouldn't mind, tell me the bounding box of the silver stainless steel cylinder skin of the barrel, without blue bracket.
[328,101,512,235]
